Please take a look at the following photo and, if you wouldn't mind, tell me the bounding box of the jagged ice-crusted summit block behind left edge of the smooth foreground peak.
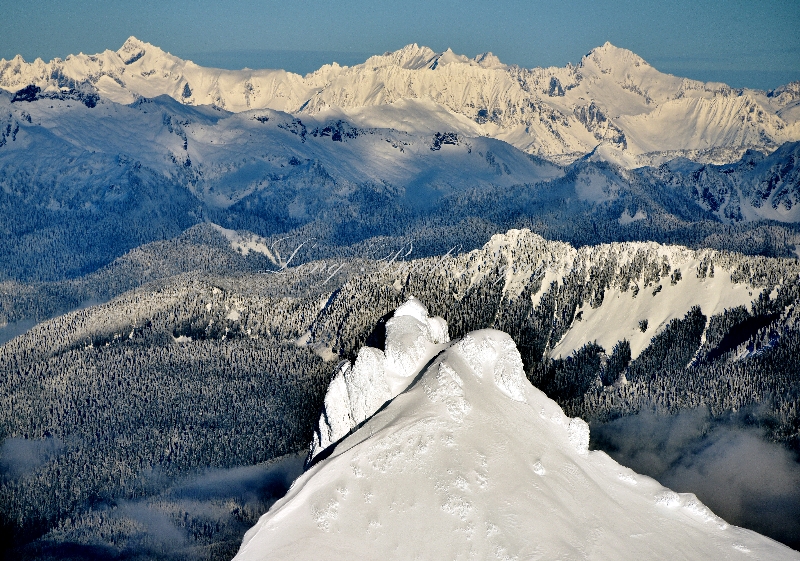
[309,296,450,461]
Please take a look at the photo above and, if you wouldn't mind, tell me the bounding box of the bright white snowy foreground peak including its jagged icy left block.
[236,300,800,560]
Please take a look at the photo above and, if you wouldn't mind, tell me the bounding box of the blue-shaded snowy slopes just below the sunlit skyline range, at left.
[0,93,563,210]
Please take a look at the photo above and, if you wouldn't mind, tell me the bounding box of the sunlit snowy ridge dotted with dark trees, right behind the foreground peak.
[418,229,800,358]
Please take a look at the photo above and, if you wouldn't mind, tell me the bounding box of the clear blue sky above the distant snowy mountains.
[0,0,800,89]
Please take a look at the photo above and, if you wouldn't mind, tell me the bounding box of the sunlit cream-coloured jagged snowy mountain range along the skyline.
[0,37,800,167]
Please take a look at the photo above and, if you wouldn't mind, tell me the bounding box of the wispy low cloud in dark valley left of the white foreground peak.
[25,452,305,560]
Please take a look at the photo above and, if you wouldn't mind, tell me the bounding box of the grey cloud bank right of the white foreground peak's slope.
[592,409,800,549]
